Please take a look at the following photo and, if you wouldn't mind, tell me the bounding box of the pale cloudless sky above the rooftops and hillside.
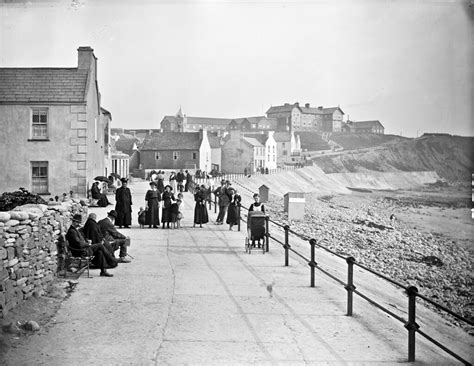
[0,0,474,137]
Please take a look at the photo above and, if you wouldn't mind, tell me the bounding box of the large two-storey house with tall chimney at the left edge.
[0,47,111,195]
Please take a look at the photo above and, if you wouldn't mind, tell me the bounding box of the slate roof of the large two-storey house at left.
[0,68,89,104]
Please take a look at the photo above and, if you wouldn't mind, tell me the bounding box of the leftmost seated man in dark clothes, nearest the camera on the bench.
[66,214,117,277]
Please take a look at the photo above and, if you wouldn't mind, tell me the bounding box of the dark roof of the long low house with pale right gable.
[141,132,201,151]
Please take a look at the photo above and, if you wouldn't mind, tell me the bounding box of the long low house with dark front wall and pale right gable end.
[140,130,212,172]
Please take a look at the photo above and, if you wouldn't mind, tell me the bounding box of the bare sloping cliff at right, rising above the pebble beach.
[313,135,474,182]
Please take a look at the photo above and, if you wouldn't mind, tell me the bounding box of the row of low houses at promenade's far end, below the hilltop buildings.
[112,128,301,174]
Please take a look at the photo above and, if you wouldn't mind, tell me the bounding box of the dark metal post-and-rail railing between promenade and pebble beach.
[238,205,474,365]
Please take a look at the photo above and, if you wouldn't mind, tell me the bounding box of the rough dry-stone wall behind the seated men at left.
[0,200,87,318]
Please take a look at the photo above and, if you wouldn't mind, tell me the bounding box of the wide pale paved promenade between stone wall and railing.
[4,183,470,365]
